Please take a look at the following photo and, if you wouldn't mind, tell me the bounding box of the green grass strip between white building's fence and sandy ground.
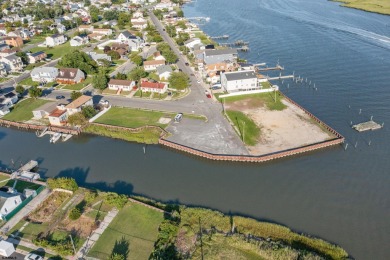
[224,92,286,111]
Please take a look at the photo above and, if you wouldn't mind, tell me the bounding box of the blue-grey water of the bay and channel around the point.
[0,0,390,259]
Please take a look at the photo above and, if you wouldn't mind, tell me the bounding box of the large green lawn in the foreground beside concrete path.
[88,204,163,260]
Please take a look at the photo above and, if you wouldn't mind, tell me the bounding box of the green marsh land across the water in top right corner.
[333,0,390,15]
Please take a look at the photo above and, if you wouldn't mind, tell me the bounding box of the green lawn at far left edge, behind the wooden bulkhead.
[3,98,51,122]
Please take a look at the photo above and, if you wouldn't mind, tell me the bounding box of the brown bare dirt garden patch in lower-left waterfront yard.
[29,191,71,222]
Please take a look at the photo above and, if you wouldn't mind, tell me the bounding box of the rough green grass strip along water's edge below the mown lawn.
[83,124,163,144]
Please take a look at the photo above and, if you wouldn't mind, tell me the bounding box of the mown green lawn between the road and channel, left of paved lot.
[95,107,173,128]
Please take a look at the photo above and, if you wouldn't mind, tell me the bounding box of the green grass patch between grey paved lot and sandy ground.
[226,110,260,145]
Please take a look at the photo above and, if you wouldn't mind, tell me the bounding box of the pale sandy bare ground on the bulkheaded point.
[229,100,333,155]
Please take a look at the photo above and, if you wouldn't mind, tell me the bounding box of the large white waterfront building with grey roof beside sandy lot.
[221,70,258,93]
